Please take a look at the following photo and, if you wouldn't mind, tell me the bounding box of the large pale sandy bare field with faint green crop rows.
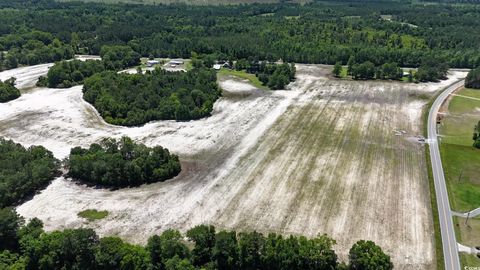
[0,62,466,269]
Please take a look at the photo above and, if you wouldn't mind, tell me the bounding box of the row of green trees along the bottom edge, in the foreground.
[0,211,393,270]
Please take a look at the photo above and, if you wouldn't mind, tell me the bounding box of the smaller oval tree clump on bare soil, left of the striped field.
[67,137,181,187]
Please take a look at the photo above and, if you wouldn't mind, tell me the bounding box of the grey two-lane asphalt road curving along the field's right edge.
[428,80,464,270]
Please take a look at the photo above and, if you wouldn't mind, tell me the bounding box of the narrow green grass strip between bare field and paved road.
[423,92,445,270]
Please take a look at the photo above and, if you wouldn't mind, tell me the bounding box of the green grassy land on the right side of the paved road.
[440,89,480,266]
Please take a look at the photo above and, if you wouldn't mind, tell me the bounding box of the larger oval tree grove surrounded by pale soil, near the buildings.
[83,68,221,126]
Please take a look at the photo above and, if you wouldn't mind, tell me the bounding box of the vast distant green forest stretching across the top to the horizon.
[0,0,480,68]
